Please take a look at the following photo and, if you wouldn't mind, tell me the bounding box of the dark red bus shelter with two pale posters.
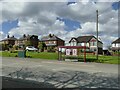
[58,46,89,62]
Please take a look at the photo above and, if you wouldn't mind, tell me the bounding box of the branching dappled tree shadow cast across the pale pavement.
[3,68,119,90]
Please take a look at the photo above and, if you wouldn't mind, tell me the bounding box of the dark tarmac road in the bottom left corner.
[2,77,55,88]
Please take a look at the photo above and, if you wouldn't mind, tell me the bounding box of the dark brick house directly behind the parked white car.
[15,34,39,48]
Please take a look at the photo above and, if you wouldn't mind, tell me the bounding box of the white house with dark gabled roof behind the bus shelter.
[69,36,103,54]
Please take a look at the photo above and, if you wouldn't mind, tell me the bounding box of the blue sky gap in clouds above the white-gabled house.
[57,17,81,31]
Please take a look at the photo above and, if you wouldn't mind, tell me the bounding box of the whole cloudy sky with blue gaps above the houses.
[0,0,119,48]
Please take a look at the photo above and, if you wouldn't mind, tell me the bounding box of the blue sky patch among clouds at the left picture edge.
[0,19,18,34]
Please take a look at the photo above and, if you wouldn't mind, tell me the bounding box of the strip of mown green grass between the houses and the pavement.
[0,51,120,64]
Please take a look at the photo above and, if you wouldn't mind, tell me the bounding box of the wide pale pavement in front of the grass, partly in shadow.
[0,57,119,89]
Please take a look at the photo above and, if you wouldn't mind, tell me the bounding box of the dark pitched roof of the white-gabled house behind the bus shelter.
[69,36,102,43]
